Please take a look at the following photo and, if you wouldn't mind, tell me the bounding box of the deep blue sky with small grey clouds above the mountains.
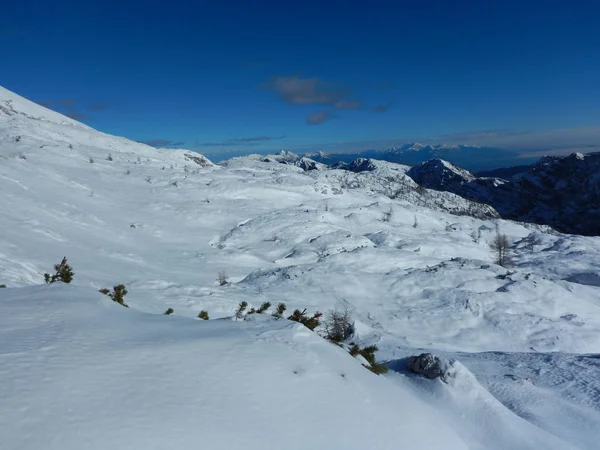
[0,0,600,154]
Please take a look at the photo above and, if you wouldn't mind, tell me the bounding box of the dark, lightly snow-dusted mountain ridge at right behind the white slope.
[407,153,600,236]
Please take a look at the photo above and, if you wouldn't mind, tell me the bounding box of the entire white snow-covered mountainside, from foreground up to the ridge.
[0,86,600,450]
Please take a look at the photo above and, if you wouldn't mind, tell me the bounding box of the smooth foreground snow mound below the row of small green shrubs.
[0,285,467,450]
